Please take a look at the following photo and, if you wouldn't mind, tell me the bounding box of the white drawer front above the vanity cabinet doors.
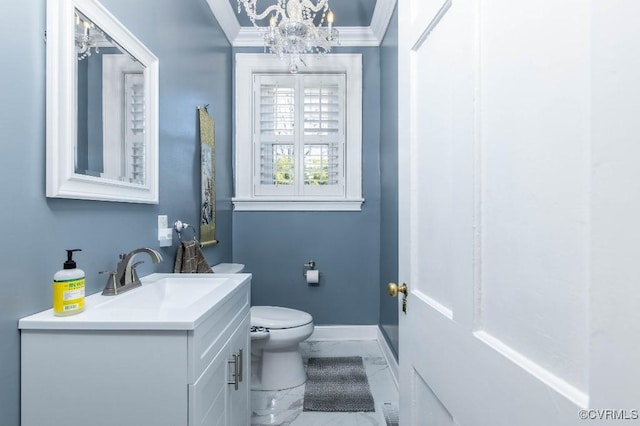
[187,281,250,384]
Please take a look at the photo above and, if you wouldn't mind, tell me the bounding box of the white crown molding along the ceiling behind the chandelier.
[207,0,396,47]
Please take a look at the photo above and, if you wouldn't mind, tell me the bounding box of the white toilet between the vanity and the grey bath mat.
[212,263,313,390]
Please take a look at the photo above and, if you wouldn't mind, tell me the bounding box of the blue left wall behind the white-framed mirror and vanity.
[0,0,232,426]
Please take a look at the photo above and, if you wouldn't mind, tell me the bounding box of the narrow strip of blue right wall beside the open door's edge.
[380,6,398,358]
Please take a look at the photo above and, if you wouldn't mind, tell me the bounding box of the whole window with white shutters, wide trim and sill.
[233,54,363,210]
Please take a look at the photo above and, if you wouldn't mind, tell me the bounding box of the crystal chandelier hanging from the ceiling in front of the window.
[238,0,339,73]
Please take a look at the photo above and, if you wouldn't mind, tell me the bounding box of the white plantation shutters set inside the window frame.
[253,74,345,196]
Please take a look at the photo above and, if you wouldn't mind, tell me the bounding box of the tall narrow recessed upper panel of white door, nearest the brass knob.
[411,5,458,316]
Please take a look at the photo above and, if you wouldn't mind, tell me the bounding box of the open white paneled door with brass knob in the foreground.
[399,0,616,426]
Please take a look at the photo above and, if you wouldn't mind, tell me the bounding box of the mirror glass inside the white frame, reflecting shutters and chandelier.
[75,9,145,185]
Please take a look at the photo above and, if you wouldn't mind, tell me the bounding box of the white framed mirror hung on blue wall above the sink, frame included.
[46,0,158,204]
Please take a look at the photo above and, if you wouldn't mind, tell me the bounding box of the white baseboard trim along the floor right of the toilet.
[307,325,398,388]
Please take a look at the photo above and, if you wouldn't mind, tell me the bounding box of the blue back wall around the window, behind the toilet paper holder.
[233,48,381,325]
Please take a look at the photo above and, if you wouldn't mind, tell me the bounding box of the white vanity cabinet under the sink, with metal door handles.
[19,274,251,426]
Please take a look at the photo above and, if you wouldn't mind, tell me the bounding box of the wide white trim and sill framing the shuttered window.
[232,53,364,211]
